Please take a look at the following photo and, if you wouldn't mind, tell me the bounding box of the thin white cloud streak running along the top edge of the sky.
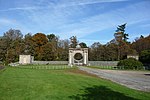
[0,0,127,11]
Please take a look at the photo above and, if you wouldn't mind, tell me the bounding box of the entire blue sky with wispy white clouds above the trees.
[0,0,150,45]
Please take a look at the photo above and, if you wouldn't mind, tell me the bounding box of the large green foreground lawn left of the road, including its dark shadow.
[0,67,150,100]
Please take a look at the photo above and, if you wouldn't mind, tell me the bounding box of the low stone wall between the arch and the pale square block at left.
[32,61,68,65]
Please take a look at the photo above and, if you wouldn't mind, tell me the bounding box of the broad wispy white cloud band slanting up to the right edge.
[51,2,150,38]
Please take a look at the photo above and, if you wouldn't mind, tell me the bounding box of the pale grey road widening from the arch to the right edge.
[79,66,150,92]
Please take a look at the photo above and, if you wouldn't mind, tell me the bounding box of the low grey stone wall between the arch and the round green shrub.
[89,61,118,66]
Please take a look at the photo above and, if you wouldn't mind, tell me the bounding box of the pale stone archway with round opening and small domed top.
[69,45,88,66]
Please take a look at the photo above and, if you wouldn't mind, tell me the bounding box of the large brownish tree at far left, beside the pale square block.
[0,29,24,63]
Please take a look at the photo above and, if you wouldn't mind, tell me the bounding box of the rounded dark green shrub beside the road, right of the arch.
[117,58,143,69]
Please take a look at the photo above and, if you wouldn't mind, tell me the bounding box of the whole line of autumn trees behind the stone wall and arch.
[0,24,150,64]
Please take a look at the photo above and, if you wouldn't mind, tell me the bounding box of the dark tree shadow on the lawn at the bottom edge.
[69,86,138,100]
